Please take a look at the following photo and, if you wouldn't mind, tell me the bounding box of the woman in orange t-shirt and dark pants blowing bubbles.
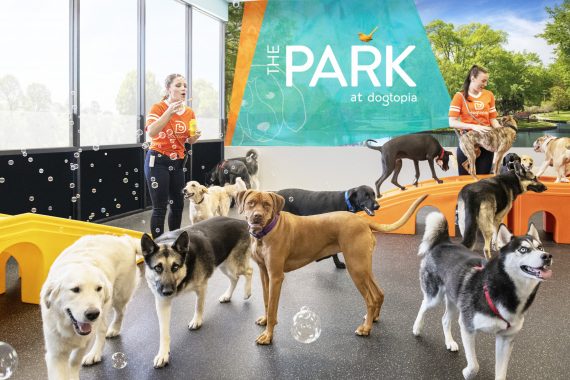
[144,74,200,238]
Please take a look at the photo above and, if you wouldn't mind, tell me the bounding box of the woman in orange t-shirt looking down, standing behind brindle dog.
[449,65,501,175]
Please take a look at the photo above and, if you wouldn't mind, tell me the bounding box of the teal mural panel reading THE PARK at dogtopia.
[232,0,450,146]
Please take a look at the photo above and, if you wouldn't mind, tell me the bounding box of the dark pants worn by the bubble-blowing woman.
[144,150,185,238]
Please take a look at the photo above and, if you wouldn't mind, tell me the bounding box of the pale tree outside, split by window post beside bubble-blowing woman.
[115,70,162,115]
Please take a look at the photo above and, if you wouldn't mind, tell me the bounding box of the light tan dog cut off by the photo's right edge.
[532,135,570,182]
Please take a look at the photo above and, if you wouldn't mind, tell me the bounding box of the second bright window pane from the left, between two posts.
[79,0,138,146]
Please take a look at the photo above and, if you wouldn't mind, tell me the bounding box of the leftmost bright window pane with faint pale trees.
[0,0,71,150]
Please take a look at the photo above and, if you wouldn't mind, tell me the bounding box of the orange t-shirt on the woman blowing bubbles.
[145,100,196,158]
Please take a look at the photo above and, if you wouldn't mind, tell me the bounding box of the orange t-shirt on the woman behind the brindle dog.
[449,89,497,126]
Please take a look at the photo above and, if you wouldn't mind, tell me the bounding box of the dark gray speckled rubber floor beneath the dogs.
[0,209,570,380]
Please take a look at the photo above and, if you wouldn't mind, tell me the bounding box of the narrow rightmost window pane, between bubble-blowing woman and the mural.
[190,9,222,139]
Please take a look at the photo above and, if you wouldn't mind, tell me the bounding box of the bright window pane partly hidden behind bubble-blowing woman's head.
[145,0,186,117]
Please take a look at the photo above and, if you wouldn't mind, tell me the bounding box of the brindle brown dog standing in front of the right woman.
[459,115,518,180]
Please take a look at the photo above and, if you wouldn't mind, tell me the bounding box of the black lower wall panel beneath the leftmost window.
[0,152,78,218]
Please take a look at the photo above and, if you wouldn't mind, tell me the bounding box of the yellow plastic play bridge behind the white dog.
[0,213,143,304]
